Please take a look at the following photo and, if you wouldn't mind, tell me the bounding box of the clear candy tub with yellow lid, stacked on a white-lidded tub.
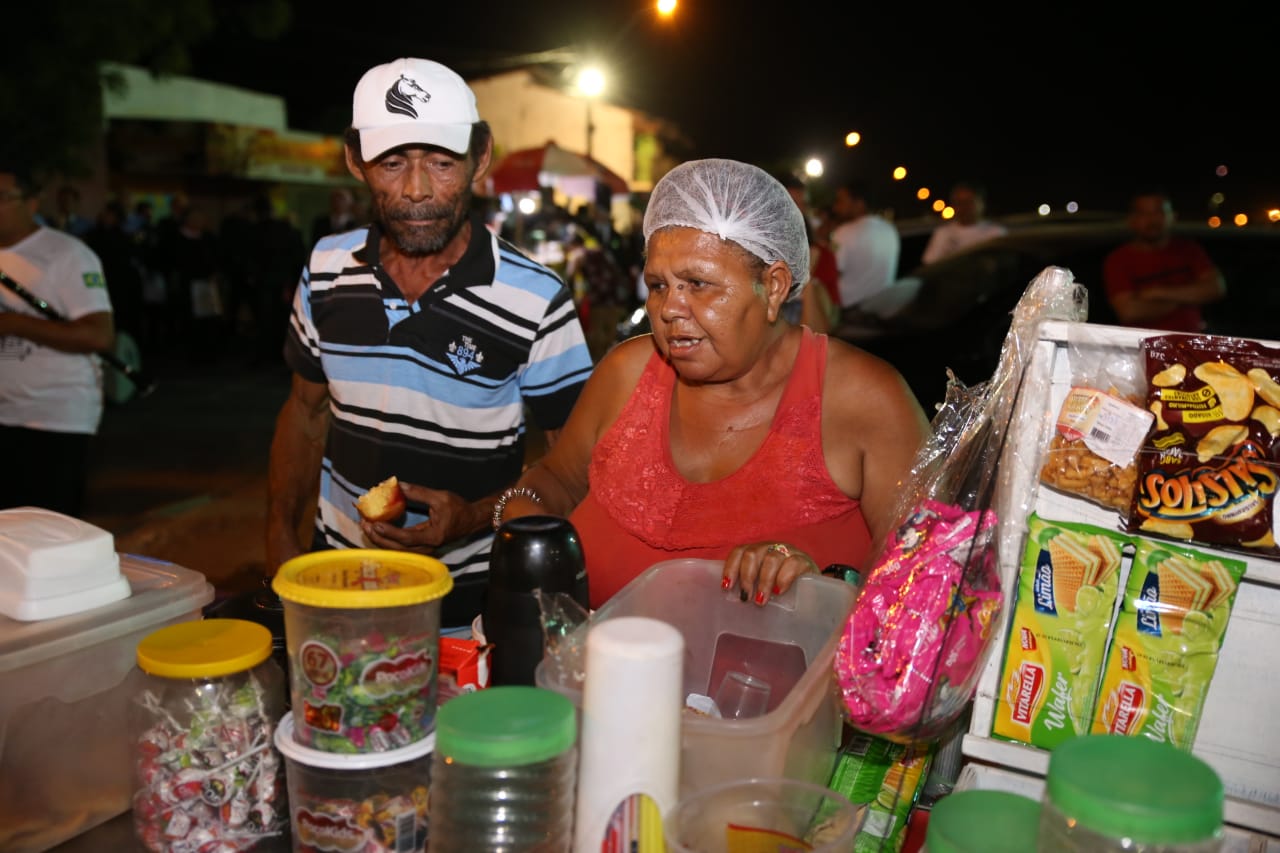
[271,549,453,753]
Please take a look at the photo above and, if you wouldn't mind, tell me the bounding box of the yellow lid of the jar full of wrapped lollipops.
[137,619,271,679]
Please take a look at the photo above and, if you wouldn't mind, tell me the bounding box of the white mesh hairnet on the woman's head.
[644,159,809,300]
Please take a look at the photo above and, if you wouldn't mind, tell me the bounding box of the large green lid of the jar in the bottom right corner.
[1046,734,1224,844]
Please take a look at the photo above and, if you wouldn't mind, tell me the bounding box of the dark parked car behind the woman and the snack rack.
[835,218,1280,411]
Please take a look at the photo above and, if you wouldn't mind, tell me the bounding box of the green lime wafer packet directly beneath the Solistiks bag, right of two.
[1093,539,1245,751]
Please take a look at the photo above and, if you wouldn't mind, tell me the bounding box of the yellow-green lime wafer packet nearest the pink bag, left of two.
[992,514,1129,749]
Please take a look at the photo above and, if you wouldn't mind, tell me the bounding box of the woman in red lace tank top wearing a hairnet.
[494,160,929,607]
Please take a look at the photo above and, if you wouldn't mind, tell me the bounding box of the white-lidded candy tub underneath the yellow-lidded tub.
[275,711,435,853]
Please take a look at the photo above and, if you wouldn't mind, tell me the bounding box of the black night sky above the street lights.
[186,0,1280,222]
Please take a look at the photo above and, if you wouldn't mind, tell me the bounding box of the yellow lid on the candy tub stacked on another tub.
[271,548,453,610]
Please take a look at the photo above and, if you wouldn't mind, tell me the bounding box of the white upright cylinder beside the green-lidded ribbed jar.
[573,616,685,853]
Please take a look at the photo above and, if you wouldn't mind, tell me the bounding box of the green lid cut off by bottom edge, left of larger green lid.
[924,789,1041,853]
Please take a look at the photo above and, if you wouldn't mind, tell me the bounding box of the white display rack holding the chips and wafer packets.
[959,321,1280,850]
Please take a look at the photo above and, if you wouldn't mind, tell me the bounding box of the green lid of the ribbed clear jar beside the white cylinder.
[435,685,577,767]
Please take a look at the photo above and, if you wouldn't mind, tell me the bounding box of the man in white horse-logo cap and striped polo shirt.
[268,59,591,628]
